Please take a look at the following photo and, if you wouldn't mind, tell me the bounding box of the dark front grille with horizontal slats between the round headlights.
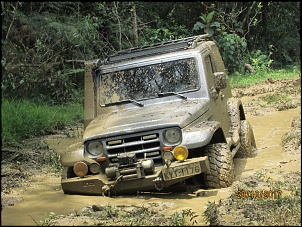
[106,133,161,163]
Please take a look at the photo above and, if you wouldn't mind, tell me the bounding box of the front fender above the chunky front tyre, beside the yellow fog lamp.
[182,121,221,149]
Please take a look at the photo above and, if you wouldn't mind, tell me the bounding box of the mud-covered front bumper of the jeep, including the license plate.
[61,157,209,196]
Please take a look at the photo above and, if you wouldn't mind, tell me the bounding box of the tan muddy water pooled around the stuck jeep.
[1,107,301,226]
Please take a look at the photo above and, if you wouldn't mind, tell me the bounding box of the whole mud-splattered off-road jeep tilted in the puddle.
[60,35,257,196]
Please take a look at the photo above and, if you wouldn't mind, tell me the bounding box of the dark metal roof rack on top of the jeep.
[104,34,209,64]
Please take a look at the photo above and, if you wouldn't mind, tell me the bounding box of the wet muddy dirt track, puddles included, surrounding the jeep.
[1,78,301,226]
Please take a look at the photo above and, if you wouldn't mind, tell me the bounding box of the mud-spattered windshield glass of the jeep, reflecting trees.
[100,58,199,106]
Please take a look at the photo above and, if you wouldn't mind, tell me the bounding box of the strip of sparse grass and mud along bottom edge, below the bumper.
[36,204,196,226]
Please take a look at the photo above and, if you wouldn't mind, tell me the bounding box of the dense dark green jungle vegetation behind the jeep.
[1,1,301,146]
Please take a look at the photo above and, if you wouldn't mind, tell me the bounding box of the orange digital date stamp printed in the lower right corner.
[235,190,282,199]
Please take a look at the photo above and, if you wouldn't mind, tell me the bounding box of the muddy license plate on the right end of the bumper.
[162,162,201,181]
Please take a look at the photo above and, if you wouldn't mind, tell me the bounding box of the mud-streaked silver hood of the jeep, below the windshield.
[83,99,209,141]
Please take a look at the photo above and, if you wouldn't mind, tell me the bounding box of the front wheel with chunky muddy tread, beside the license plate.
[204,143,235,188]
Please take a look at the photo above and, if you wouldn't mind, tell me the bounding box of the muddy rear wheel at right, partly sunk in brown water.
[235,120,258,158]
